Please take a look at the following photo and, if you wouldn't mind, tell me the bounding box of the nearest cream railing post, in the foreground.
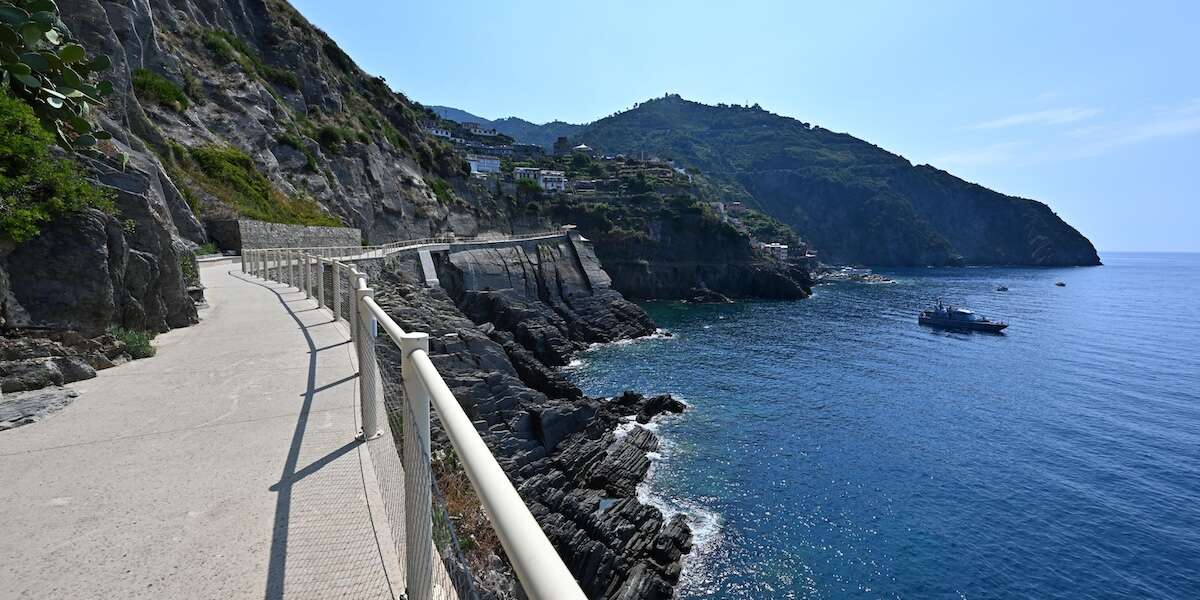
[400,334,433,600]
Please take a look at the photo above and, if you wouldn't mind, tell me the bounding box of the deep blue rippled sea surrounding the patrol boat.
[568,253,1200,600]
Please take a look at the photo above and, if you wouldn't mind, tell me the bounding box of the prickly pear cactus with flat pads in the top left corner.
[0,0,113,149]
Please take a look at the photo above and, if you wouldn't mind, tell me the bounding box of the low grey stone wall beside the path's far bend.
[204,218,362,251]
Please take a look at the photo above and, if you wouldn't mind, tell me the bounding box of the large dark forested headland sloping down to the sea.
[576,95,1099,266]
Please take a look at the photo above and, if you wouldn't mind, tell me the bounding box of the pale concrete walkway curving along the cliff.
[0,262,403,600]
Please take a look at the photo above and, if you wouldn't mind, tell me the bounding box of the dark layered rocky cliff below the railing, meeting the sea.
[372,240,691,599]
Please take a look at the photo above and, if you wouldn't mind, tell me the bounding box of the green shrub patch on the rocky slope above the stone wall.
[187,145,342,227]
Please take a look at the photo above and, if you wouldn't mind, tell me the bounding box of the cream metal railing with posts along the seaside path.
[242,230,586,600]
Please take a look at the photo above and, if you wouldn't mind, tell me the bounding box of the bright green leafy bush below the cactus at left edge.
[0,92,116,244]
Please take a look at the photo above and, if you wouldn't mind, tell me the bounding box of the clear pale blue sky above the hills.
[293,0,1200,252]
